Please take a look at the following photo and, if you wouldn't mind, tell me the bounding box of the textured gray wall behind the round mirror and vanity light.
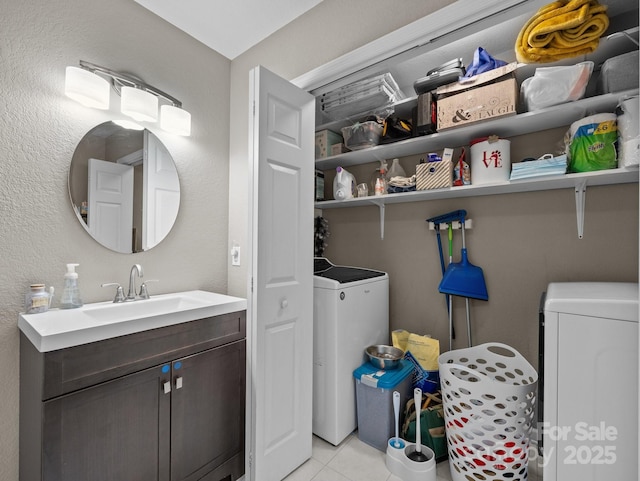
[0,0,230,481]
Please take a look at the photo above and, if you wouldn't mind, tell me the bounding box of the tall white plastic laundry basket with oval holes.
[438,343,538,481]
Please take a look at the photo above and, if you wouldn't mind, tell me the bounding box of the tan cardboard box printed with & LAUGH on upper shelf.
[437,78,519,131]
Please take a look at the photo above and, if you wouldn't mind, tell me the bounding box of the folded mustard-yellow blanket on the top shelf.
[515,0,609,63]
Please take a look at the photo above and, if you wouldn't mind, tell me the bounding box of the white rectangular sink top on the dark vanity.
[18,291,247,352]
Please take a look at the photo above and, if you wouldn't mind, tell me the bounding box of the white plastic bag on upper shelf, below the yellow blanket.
[520,61,593,110]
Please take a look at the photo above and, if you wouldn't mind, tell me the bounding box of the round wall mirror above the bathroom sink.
[69,122,180,253]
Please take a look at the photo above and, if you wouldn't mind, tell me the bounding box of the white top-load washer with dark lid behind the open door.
[312,257,389,446]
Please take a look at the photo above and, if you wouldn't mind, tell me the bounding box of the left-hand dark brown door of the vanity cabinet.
[42,365,171,481]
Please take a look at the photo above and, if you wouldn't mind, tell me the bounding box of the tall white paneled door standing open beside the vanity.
[246,67,315,481]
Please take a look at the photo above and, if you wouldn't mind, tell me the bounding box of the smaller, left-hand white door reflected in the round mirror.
[87,159,133,253]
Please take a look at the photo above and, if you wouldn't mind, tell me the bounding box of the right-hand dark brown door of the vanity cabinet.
[171,340,245,481]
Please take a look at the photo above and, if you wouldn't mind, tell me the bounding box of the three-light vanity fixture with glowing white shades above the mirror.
[65,60,191,136]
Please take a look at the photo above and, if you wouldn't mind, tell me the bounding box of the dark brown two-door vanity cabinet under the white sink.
[20,312,246,481]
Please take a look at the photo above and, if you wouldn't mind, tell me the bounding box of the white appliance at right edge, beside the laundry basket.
[538,282,638,481]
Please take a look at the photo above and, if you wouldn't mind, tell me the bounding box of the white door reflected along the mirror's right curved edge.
[142,130,180,250]
